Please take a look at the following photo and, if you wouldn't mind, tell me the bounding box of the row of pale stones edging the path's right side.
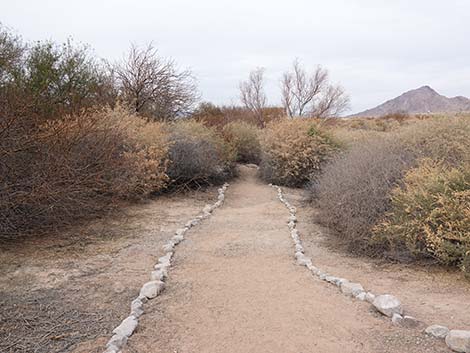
[269,184,470,353]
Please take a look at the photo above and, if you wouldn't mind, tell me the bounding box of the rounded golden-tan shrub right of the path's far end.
[260,119,340,186]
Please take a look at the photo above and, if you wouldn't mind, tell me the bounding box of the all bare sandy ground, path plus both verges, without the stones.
[0,167,470,353]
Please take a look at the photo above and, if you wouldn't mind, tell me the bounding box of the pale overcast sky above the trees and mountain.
[0,0,470,112]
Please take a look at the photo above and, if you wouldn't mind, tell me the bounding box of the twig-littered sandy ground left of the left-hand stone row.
[0,189,217,353]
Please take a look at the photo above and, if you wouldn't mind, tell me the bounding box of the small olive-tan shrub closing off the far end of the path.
[223,121,261,164]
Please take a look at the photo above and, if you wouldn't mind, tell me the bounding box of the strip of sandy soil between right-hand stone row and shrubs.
[286,189,470,330]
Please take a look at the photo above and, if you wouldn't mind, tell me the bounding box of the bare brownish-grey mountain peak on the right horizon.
[351,86,470,117]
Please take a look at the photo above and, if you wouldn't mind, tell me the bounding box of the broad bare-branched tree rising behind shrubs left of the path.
[114,44,199,120]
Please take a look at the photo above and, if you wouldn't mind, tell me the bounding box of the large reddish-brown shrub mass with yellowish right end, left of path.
[0,107,167,236]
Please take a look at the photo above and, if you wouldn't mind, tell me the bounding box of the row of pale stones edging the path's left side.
[104,183,229,353]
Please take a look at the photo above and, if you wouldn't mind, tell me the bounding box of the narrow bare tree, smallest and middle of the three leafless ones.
[240,68,267,127]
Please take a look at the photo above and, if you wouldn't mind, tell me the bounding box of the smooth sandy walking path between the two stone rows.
[124,167,446,353]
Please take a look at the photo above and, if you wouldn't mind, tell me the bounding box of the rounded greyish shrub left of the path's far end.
[168,120,235,188]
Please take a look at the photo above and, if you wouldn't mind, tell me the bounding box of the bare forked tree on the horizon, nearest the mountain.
[281,59,349,118]
